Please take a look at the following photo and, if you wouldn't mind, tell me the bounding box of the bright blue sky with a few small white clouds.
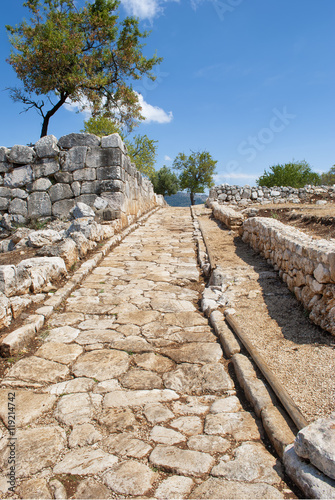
[0,0,335,185]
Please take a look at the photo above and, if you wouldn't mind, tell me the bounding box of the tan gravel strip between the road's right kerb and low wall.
[195,205,335,422]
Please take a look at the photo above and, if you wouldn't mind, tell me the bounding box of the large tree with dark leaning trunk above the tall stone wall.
[6,0,161,137]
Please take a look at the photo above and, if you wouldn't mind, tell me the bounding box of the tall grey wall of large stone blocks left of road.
[0,134,162,225]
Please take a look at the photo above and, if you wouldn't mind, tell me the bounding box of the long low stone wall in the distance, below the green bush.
[207,184,335,206]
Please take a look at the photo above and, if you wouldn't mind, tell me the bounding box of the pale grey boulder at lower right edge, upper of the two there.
[294,412,335,479]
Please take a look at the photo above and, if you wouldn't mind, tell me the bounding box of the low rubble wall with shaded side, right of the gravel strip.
[240,217,335,335]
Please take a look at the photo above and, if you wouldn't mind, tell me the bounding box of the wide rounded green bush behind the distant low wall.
[256,160,320,188]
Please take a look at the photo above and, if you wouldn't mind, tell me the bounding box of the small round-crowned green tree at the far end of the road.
[173,151,217,205]
